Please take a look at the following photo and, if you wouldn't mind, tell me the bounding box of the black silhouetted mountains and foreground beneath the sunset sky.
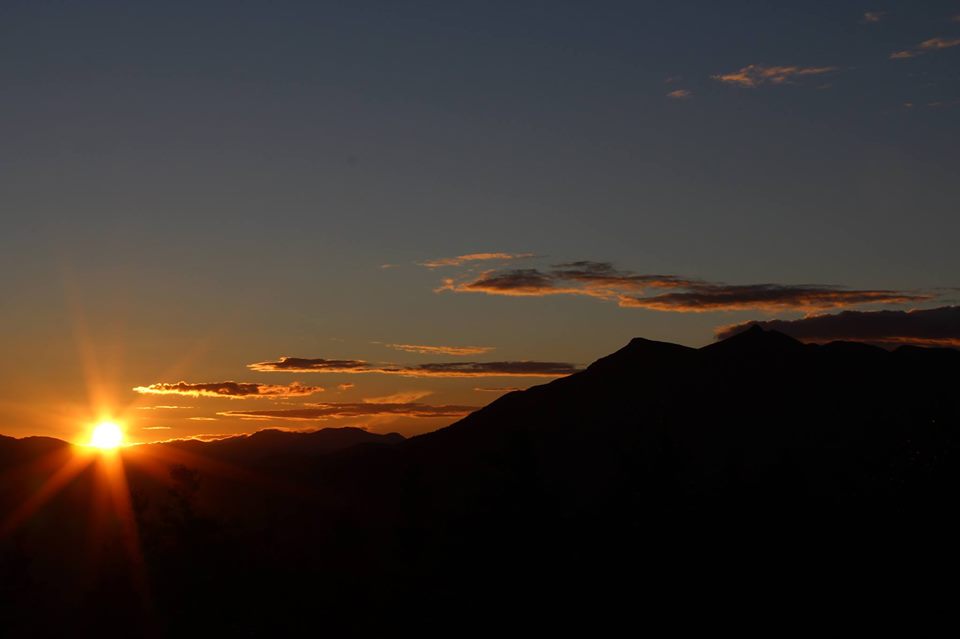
[0,329,960,636]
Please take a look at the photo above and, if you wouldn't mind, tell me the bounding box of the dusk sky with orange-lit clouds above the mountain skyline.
[0,0,960,441]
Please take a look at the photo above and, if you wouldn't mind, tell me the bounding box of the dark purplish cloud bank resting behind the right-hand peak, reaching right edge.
[716,306,960,348]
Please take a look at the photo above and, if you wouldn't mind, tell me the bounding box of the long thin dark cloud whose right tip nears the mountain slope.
[247,357,578,377]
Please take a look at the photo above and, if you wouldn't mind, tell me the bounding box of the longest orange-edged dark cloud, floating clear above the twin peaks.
[436,261,931,313]
